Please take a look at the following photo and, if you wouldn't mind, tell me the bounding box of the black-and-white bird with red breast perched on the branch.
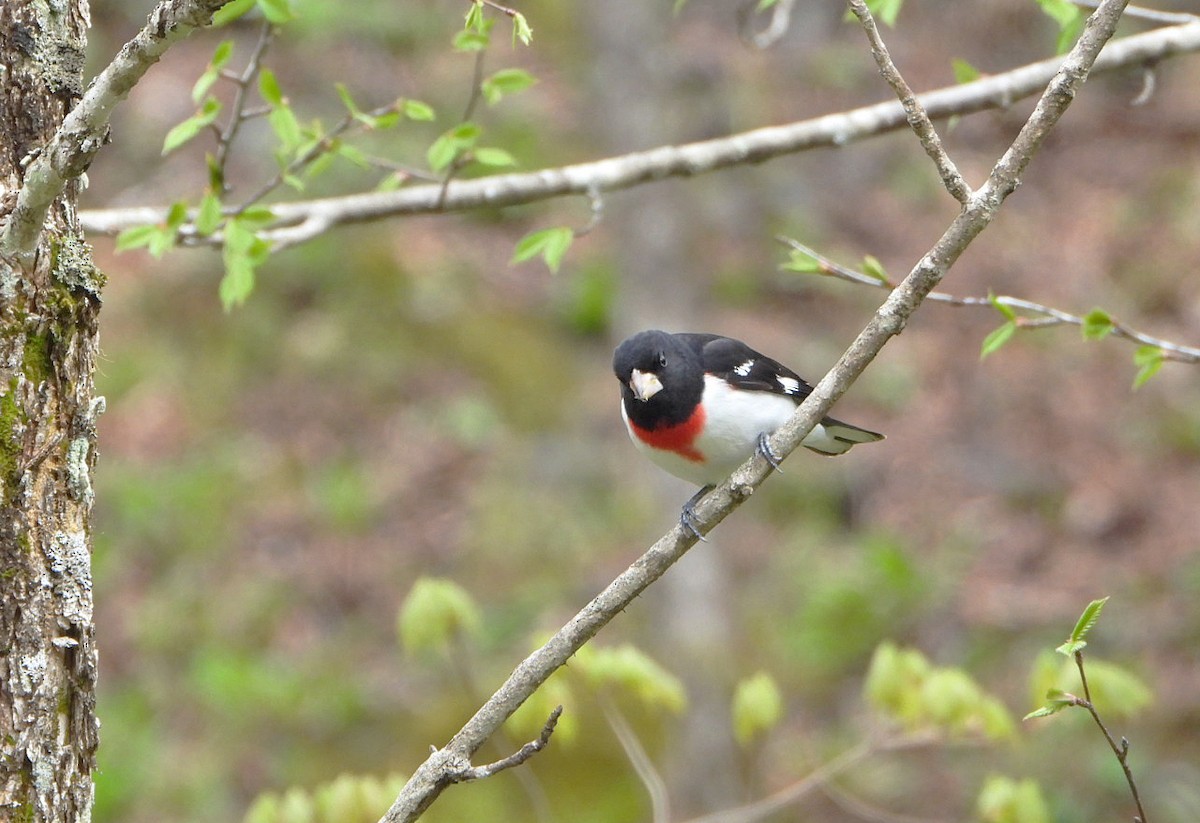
[612,329,883,540]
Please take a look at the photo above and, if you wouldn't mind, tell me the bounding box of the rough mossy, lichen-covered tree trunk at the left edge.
[0,0,103,823]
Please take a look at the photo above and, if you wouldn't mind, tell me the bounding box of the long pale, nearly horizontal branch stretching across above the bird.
[79,22,1200,248]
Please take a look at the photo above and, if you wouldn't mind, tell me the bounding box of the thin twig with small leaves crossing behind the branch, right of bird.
[775,235,1200,364]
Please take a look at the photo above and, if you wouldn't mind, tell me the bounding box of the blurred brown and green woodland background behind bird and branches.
[77,0,1200,823]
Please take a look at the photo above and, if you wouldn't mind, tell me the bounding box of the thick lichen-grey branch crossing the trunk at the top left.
[0,0,229,254]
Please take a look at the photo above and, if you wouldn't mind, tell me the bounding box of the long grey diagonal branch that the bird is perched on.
[383,0,1127,823]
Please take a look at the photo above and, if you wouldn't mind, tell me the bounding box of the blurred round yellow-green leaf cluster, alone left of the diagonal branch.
[396,577,484,654]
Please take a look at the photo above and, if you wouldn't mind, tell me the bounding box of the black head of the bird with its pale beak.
[612,330,704,427]
